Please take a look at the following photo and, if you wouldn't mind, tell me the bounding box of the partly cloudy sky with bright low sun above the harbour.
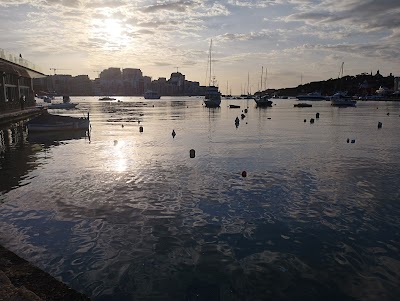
[0,0,400,94]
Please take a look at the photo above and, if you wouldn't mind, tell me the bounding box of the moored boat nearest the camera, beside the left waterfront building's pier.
[26,111,90,132]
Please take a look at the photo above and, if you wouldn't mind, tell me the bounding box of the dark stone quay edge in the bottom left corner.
[0,245,91,301]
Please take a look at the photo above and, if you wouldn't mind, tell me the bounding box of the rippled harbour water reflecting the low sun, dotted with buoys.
[0,97,400,301]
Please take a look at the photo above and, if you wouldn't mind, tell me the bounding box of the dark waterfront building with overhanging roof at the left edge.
[0,49,46,114]
